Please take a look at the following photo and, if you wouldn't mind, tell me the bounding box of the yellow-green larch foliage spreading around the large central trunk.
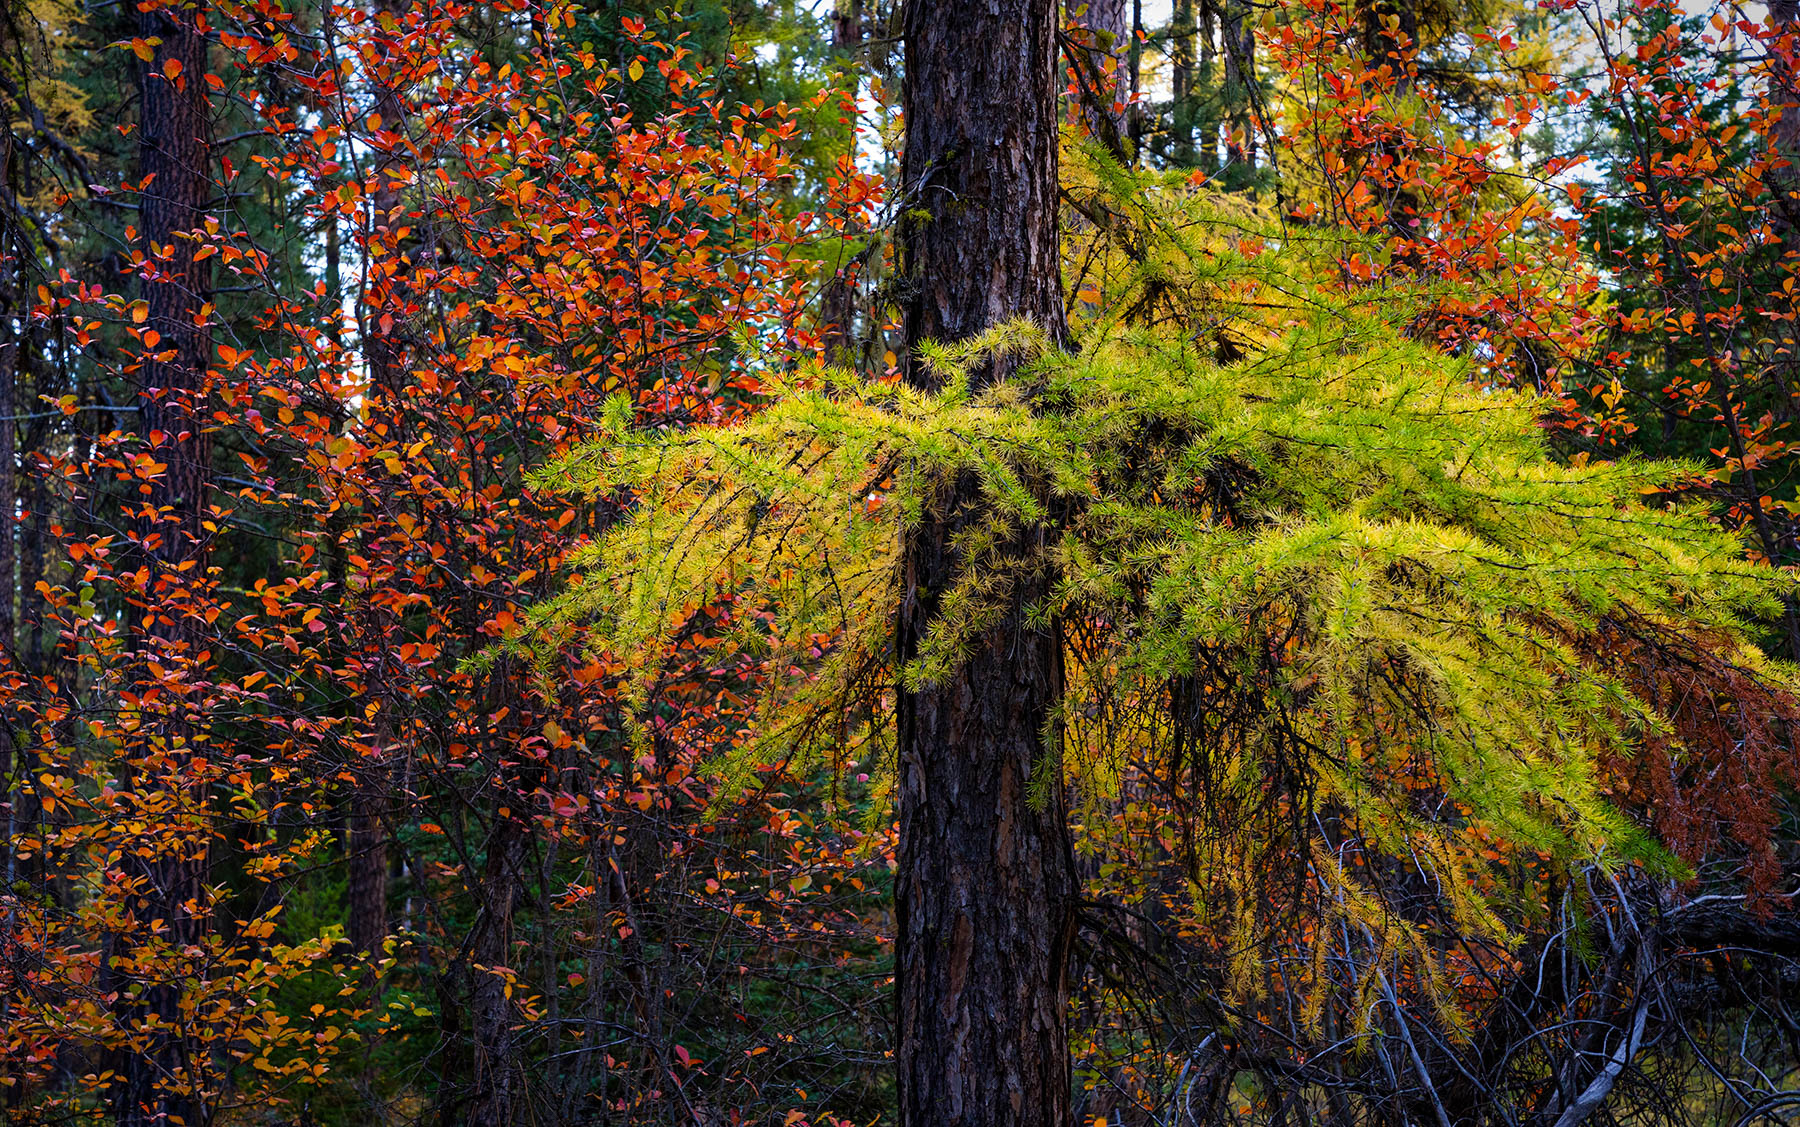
[529,144,1795,1015]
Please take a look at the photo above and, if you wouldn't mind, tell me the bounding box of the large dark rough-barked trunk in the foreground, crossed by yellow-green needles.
[895,0,1075,1127]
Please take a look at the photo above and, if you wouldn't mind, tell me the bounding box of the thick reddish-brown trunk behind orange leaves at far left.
[113,9,214,1127]
